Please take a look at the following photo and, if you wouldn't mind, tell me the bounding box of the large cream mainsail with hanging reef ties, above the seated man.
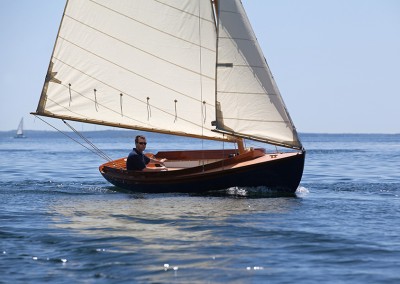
[36,0,231,140]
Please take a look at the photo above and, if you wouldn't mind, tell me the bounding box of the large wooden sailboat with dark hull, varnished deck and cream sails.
[32,0,305,193]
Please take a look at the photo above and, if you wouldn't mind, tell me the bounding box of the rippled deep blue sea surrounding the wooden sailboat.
[0,131,400,283]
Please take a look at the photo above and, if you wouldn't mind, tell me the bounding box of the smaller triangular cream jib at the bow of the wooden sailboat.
[217,0,301,148]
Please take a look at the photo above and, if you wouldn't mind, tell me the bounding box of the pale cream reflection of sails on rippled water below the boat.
[49,194,301,246]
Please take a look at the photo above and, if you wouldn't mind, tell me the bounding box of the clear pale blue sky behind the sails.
[0,0,400,133]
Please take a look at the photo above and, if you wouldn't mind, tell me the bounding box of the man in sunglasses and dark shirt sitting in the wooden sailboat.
[126,135,168,172]
